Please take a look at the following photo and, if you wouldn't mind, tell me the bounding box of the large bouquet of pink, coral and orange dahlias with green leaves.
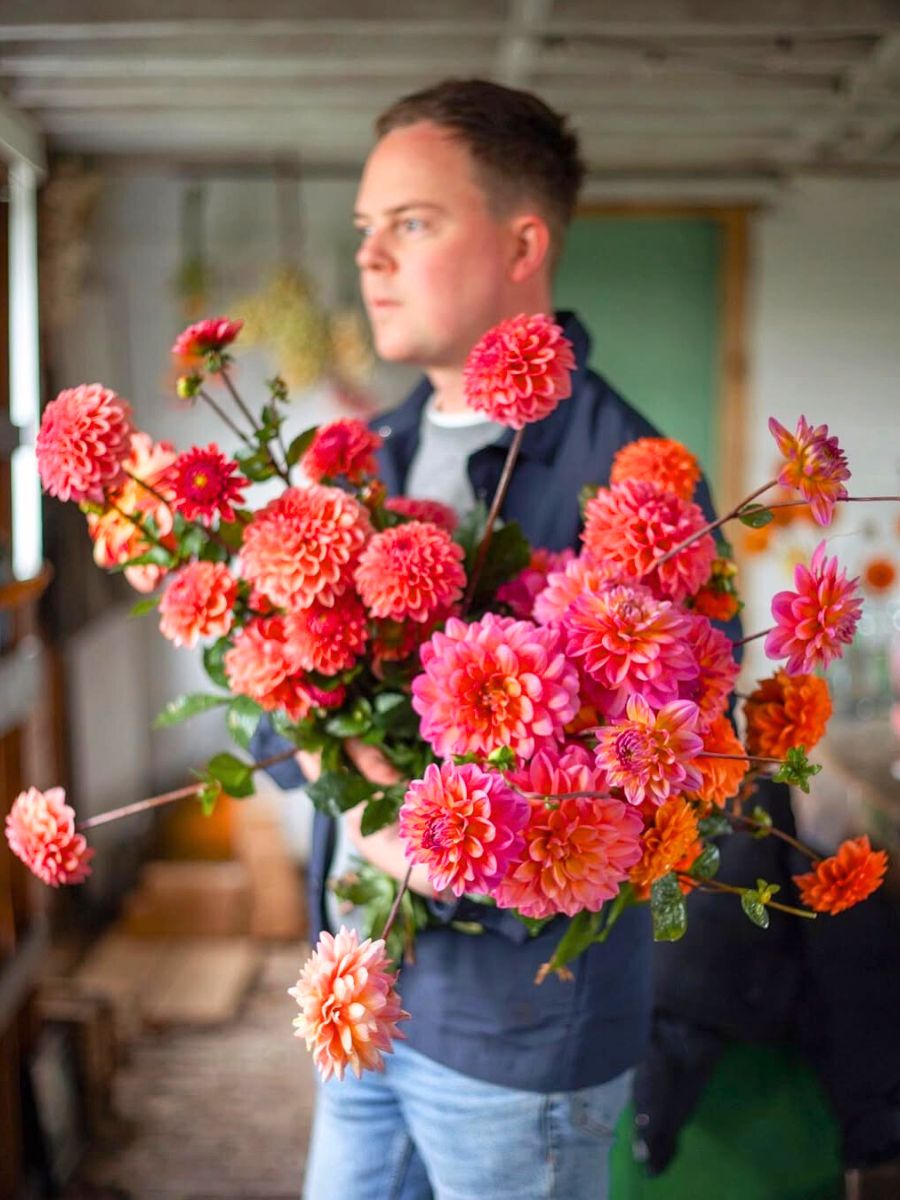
[7,316,900,1078]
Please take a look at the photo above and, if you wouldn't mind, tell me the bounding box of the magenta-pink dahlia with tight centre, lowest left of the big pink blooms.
[400,762,528,896]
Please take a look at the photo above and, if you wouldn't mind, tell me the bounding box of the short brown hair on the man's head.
[376,79,584,254]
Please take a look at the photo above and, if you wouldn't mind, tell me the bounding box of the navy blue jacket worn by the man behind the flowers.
[253,313,724,1092]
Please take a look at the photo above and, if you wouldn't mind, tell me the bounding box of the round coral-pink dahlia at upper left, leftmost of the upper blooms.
[35,383,133,504]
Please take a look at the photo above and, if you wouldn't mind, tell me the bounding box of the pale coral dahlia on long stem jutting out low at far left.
[6,787,94,888]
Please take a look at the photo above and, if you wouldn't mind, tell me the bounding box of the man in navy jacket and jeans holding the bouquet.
[257,80,710,1200]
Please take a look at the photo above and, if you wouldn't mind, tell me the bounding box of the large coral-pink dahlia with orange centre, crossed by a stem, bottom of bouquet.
[494,749,643,919]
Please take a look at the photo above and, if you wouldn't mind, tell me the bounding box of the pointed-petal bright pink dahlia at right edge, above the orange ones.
[766,541,863,676]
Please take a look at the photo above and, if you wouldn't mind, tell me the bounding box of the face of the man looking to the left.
[355,121,515,370]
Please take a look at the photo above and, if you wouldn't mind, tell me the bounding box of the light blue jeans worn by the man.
[304,1042,632,1200]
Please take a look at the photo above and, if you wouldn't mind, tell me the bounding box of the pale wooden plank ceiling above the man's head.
[0,0,900,178]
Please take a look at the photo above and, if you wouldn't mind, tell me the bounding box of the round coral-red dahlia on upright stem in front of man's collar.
[463,313,575,430]
